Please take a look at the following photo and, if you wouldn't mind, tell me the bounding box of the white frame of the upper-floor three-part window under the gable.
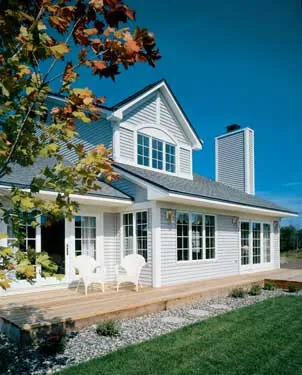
[134,131,179,176]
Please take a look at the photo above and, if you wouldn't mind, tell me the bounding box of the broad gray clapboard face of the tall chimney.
[216,131,245,191]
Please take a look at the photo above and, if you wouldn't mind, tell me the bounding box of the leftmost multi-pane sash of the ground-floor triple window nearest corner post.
[176,212,189,261]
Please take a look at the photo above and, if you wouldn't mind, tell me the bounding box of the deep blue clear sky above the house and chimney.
[52,0,302,226]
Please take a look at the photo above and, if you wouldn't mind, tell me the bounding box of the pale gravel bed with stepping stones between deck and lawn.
[0,290,302,375]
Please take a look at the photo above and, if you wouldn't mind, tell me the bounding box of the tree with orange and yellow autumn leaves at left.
[0,0,160,288]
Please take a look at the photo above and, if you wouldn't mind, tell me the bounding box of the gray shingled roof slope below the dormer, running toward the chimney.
[115,163,295,213]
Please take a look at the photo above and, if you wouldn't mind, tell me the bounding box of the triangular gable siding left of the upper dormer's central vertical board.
[123,94,156,125]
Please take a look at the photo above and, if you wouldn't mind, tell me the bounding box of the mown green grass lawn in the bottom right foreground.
[59,296,302,375]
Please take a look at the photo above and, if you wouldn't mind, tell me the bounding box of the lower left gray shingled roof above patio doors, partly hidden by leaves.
[0,158,131,200]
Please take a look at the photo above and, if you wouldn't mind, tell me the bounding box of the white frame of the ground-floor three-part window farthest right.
[239,219,273,269]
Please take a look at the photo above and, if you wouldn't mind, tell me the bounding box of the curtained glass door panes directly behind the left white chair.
[74,216,96,258]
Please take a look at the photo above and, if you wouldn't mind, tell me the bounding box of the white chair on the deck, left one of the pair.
[74,255,105,296]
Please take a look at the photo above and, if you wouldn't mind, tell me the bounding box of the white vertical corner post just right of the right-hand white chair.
[152,201,161,288]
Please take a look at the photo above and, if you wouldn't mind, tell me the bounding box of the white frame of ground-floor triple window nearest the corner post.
[175,210,218,265]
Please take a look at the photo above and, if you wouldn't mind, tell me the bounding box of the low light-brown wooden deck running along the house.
[0,269,302,343]
